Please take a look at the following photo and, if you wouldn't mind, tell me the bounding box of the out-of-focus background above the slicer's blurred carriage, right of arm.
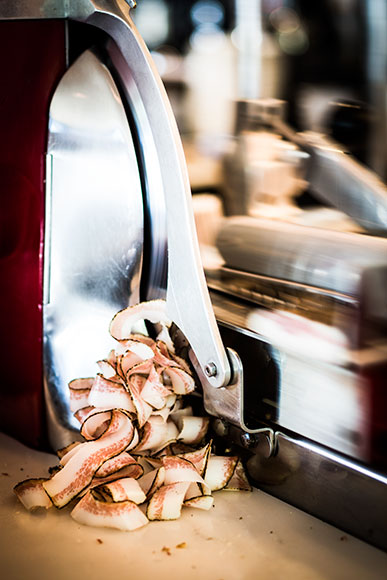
[132,0,387,214]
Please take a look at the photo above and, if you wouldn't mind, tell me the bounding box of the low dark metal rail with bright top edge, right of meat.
[247,432,387,550]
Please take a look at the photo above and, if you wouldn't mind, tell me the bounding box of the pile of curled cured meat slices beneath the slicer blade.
[14,300,251,530]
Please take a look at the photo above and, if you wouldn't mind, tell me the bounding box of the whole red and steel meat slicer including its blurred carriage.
[0,0,387,548]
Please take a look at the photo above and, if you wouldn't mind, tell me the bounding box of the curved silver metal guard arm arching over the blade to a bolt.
[0,0,231,440]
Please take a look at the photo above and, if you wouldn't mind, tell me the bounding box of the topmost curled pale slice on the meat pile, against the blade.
[110,300,170,340]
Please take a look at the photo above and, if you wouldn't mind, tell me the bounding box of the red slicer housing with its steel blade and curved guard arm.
[0,0,241,448]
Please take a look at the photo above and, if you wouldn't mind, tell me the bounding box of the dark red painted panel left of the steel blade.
[0,21,65,447]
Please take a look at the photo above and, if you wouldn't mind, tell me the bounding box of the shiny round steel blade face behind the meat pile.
[43,51,143,447]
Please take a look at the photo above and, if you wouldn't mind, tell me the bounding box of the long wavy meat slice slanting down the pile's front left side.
[43,409,135,507]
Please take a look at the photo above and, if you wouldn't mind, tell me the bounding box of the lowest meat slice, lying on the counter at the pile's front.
[71,491,148,530]
